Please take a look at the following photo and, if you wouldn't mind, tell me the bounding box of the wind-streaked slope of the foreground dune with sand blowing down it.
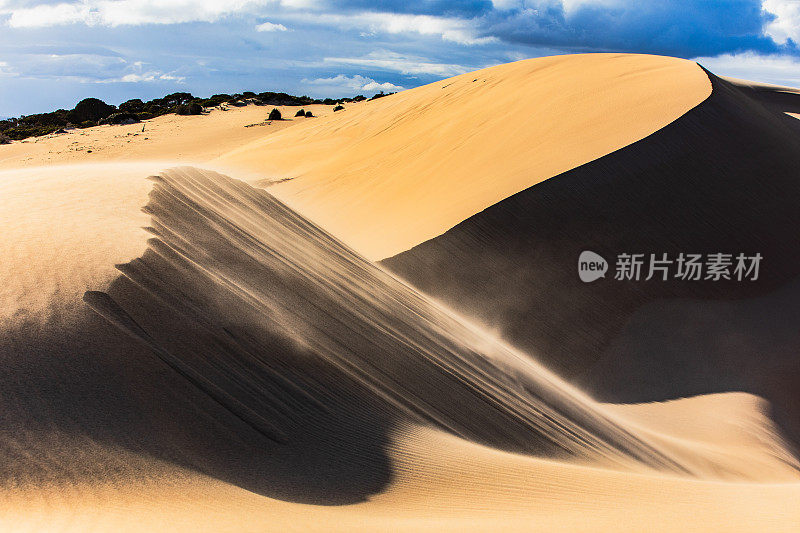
[84,168,685,471]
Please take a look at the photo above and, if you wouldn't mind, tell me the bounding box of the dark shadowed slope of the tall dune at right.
[383,70,800,442]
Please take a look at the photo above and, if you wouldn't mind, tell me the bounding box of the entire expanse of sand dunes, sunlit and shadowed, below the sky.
[0,55,800,532]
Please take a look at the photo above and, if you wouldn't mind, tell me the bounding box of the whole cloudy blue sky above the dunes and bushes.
[0,0,800,116]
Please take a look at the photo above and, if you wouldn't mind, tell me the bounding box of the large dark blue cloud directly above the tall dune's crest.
[480,0,781,57]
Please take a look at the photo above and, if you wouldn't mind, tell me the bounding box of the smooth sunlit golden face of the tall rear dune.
[213,54,711,259]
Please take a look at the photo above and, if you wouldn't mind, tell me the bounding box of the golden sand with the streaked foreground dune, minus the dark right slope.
[0,55,800,532]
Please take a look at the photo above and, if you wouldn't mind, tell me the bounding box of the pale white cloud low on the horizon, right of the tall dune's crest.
[695,52,800,87]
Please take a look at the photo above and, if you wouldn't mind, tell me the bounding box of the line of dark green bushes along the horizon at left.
[0,91,396,144]
